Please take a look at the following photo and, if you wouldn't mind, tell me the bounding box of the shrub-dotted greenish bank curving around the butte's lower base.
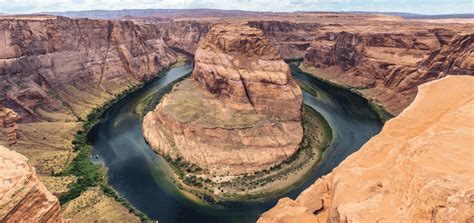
[164,105,332,203]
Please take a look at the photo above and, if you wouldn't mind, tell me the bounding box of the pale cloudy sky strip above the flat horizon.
[0,0,474,15]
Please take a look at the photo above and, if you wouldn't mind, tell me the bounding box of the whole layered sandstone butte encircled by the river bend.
[143,24,303,175]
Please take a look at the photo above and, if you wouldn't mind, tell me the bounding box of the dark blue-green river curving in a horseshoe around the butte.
[89,60,382,223]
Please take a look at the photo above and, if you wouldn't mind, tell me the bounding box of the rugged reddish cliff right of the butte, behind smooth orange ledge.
[304,26,474,115]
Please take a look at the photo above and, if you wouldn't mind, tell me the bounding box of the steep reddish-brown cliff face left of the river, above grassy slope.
[0,16,176,122]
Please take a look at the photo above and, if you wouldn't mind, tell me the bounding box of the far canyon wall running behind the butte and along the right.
[155,17,474,115]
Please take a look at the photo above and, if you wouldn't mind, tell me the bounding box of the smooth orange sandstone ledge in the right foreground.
[258,76,474,223]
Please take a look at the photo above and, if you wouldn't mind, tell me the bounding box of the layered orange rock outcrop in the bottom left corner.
[0,146,63,223]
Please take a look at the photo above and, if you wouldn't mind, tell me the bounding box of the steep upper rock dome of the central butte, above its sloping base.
[192,25,302,121]
